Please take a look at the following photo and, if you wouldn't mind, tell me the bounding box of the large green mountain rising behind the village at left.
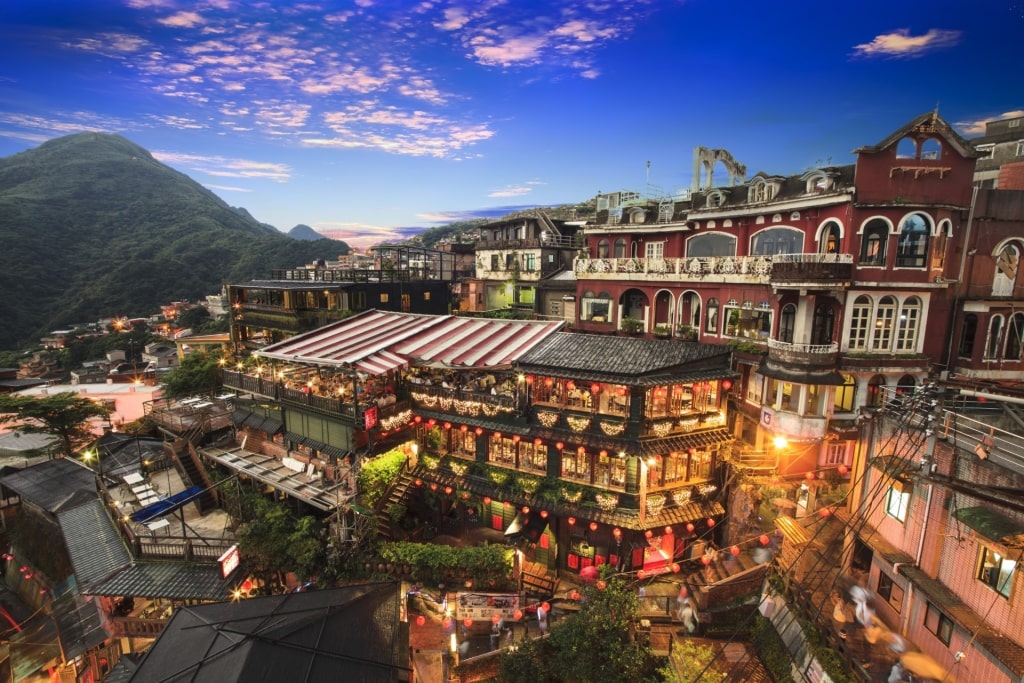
[0,133,348,349]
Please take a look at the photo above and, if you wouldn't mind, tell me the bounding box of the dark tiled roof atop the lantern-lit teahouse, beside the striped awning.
[518,333,733,384]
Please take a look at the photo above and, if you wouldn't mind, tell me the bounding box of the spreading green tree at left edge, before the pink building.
[0,391,111,457]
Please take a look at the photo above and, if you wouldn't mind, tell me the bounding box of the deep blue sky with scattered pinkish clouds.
[0,0,1024,247]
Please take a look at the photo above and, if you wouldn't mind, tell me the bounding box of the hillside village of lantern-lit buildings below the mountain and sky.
[0,112,1024,681]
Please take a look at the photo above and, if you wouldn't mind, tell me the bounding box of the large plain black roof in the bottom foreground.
[132,583,410,683]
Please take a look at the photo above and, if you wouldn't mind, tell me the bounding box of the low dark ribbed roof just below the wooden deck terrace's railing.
[82,561,232,600]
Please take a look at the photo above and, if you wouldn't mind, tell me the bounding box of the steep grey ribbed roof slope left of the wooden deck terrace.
[57,498,131,587]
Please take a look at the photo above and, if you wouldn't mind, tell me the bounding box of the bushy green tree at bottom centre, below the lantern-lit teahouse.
[501,578,657,683]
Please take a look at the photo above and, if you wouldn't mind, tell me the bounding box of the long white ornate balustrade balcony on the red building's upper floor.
[574,256,772,285]
